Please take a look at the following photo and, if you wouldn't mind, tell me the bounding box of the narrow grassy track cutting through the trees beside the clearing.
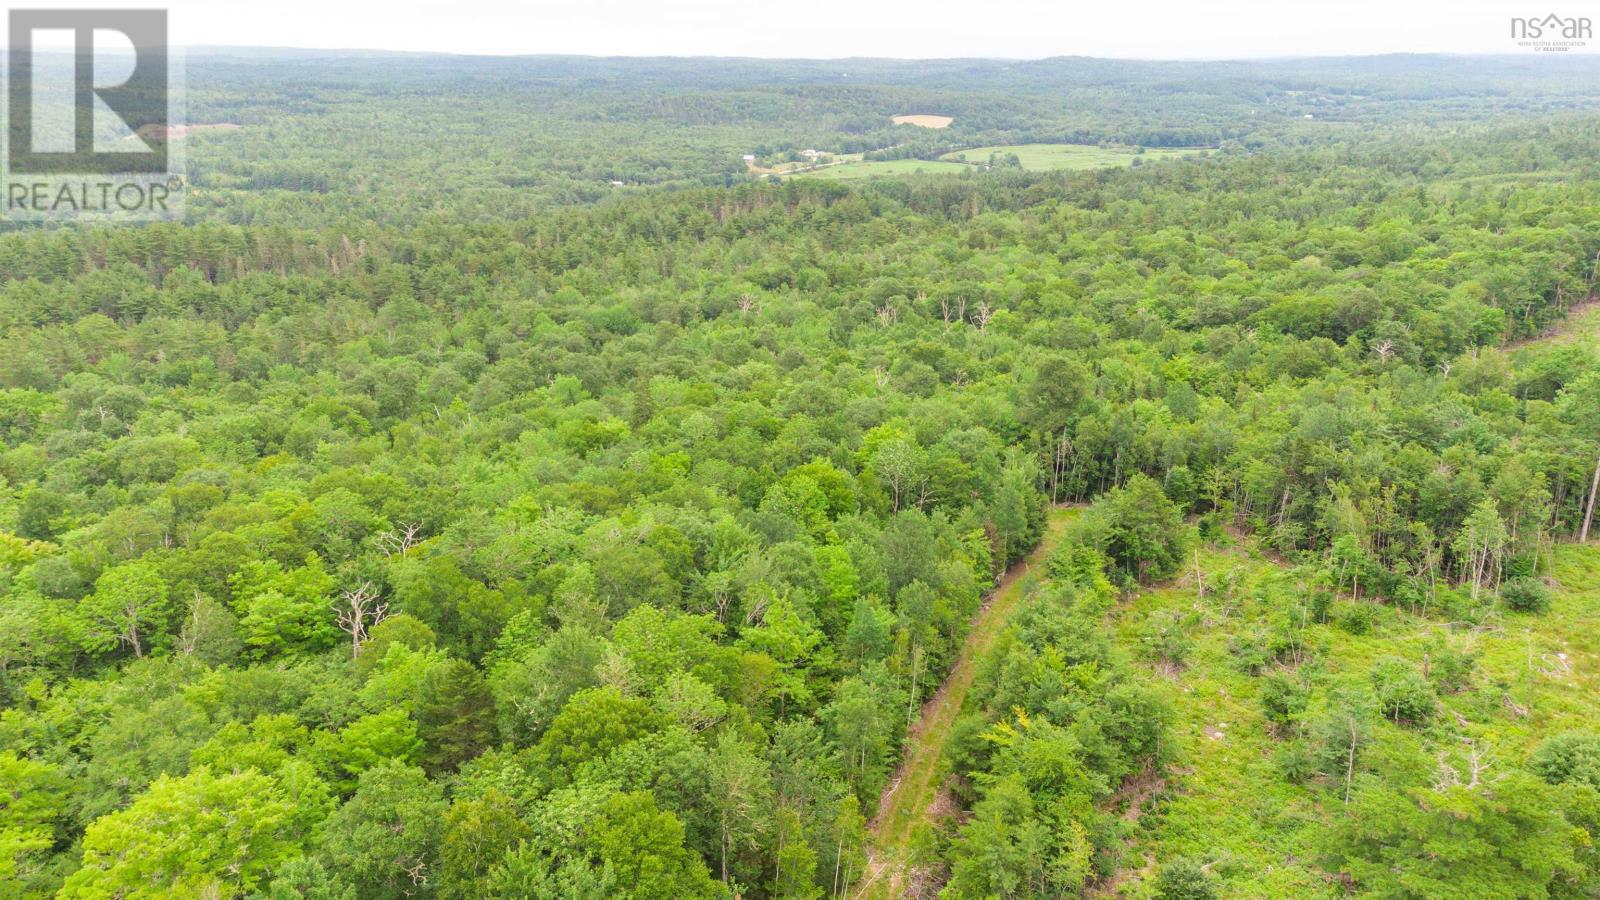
[858,506,1075,897]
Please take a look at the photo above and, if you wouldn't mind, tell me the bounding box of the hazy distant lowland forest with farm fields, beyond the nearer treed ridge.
[156,50,1600,225]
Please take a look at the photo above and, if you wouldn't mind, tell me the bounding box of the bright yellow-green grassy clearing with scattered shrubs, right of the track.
[1110,531,1600,897]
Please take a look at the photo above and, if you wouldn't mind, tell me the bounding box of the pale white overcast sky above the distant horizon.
[15,0,1600,61]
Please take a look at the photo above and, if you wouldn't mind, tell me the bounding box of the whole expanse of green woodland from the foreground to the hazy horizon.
[0,56,1600,900]
